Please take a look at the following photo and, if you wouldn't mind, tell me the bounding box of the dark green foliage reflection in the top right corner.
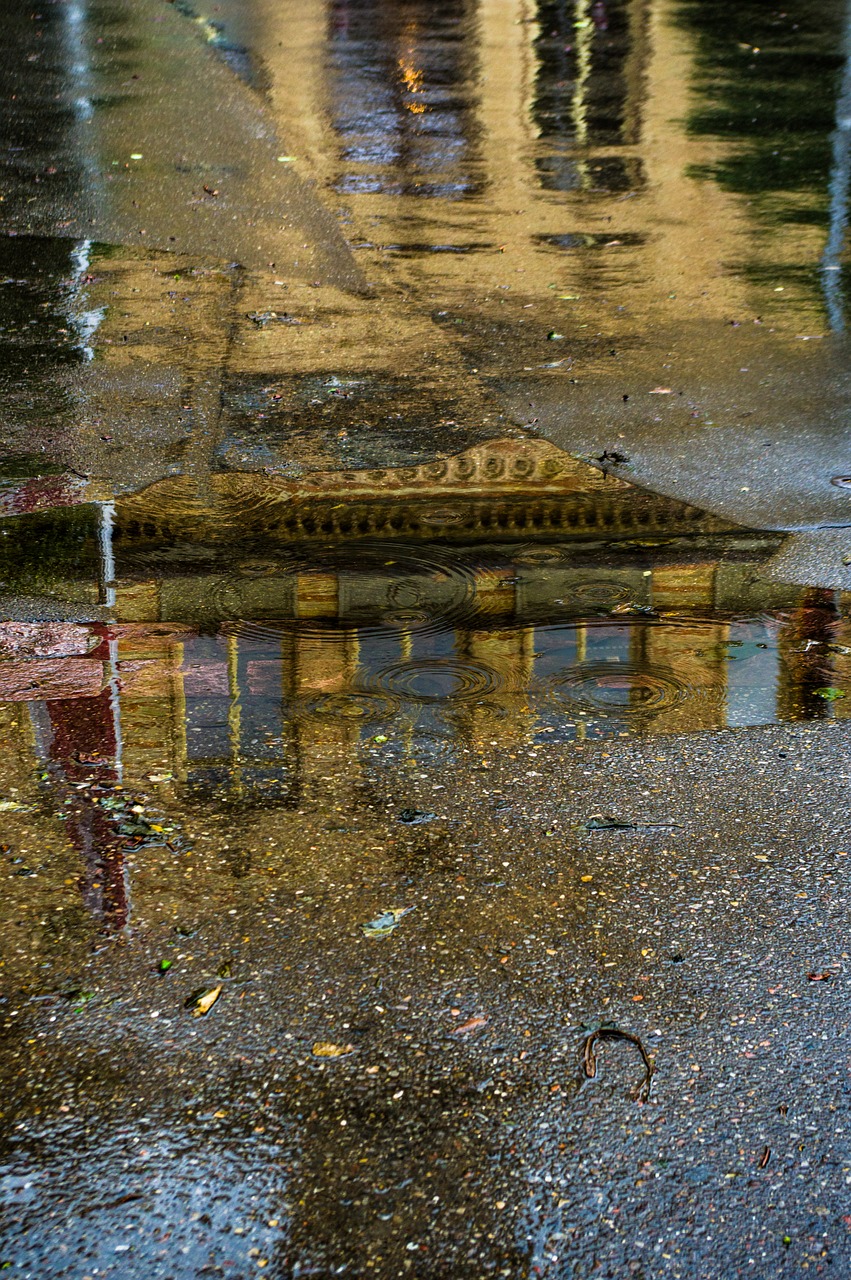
[678,0,848,332]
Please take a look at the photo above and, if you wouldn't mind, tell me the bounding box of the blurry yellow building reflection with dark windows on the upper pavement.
[4,0,843,519]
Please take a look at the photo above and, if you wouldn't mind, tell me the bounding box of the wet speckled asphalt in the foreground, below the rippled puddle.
[3,724,851,1277]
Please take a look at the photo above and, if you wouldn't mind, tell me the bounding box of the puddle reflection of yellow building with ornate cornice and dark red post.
[0,440,851,952]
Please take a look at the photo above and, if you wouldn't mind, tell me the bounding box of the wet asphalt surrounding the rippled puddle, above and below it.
[0,0,851,1280]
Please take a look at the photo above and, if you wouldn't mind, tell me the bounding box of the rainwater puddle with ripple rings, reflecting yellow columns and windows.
[0,494,851,805]
